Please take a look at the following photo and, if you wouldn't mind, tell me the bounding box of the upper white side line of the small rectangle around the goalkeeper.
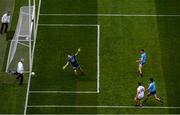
[39,24,98,27]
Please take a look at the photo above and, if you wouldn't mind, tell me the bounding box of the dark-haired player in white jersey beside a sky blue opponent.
[134,82,145,106]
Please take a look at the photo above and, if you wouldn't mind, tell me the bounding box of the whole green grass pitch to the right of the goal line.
[0,0,180,114]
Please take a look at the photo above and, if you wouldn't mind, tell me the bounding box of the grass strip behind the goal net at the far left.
[0,0,27,114]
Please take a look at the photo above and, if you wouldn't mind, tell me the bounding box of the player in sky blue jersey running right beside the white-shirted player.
[144,78,163,103]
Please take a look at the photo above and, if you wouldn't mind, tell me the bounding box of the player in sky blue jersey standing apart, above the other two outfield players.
[136,49,146,77]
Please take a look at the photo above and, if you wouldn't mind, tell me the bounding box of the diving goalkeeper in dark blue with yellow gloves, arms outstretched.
[63,48,85,75]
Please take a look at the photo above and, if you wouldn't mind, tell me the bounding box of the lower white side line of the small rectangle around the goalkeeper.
[29,91,98,94]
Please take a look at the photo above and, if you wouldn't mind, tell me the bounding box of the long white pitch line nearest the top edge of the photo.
[40,14,180,17]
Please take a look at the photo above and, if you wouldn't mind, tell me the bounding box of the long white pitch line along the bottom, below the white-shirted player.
[28,105,180,109]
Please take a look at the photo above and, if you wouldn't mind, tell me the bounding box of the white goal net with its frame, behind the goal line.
[6,6,34,72]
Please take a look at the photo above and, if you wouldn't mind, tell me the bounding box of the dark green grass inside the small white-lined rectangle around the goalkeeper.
[31,26,97,91]
